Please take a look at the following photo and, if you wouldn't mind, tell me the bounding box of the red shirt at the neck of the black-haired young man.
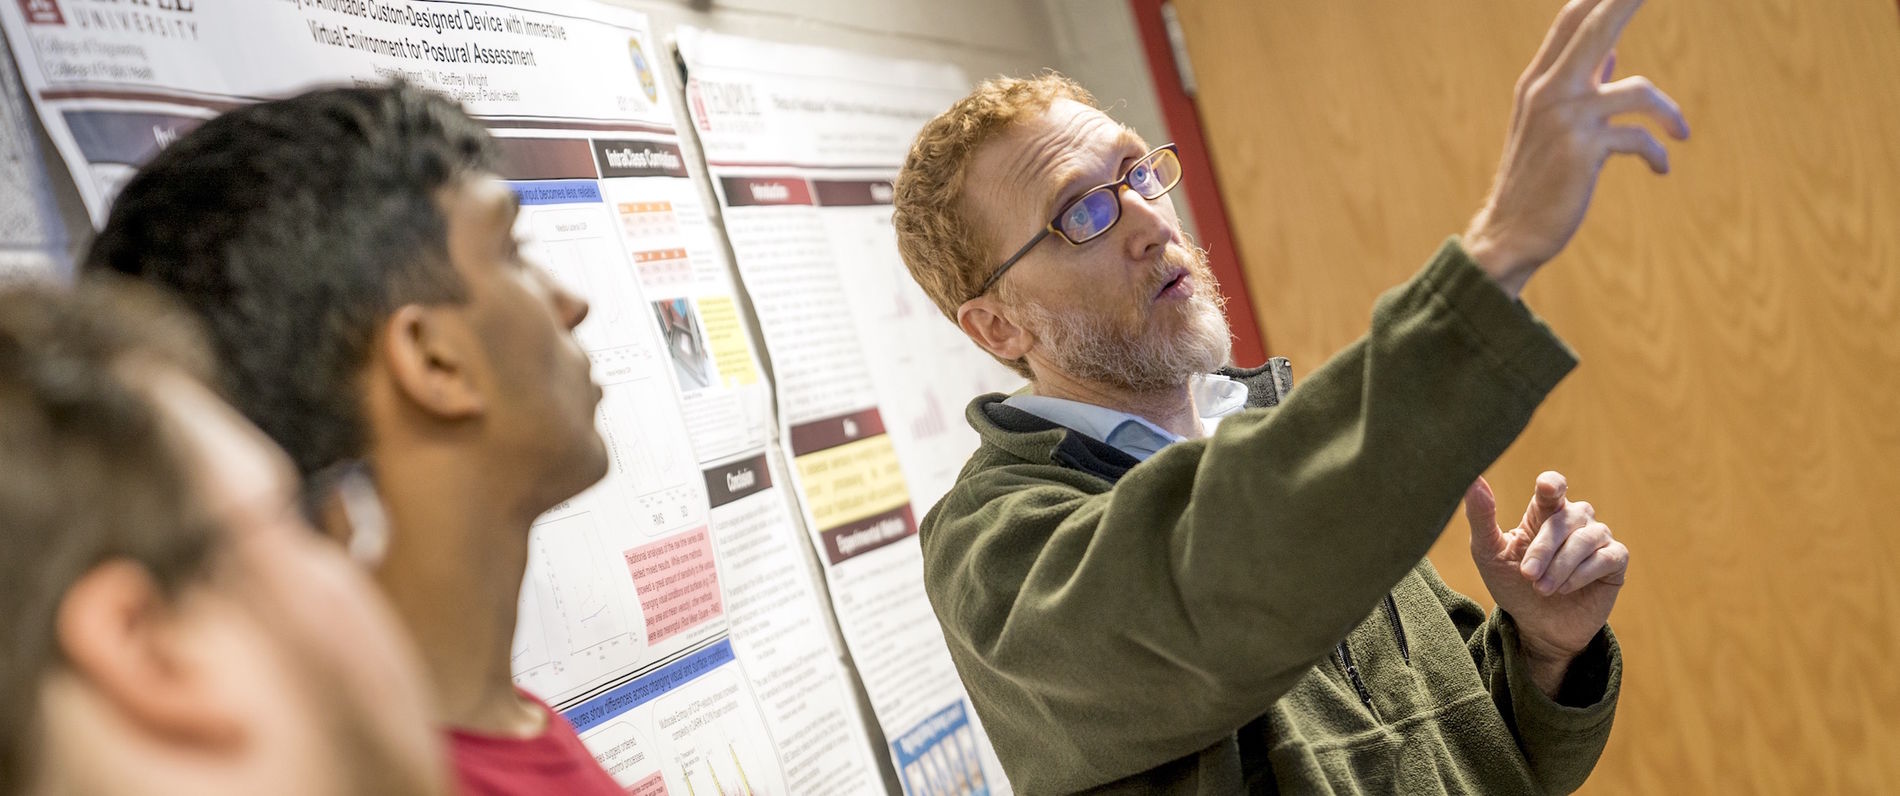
[448,692,625,796]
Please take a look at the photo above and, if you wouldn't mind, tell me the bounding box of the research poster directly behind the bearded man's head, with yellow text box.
[676,28,1022,794]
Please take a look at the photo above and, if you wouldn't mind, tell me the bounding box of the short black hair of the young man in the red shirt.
[87,84,496,477]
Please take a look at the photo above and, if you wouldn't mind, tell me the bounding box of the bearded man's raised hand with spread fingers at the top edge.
[1465,0,1689,296]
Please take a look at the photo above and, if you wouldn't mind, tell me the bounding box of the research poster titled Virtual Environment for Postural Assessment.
[0,0,880,794]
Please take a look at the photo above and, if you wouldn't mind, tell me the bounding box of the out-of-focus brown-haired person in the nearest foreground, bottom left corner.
[0,285,447,796]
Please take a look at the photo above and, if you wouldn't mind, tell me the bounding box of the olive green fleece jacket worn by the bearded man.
[922,239,1621,794]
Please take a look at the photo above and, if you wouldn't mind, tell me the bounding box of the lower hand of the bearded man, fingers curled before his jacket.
[1465,473,1630,697]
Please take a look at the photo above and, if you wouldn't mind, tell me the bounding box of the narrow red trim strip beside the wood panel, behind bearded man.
[1129,0,1267,367]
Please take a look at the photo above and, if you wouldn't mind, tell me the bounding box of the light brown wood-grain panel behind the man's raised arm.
[1176,0,1900,794]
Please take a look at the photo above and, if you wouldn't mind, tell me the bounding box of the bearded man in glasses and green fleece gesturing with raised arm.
[897,0,1687,794]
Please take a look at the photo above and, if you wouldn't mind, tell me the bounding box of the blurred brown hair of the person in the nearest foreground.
[0,281,215,794]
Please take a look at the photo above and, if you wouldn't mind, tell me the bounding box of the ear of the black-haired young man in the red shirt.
[378,304,486,420]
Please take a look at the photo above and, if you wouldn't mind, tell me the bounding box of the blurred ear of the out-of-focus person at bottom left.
[53,560,245,750]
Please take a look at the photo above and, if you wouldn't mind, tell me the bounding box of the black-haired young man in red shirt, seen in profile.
[87,84,621,796]
